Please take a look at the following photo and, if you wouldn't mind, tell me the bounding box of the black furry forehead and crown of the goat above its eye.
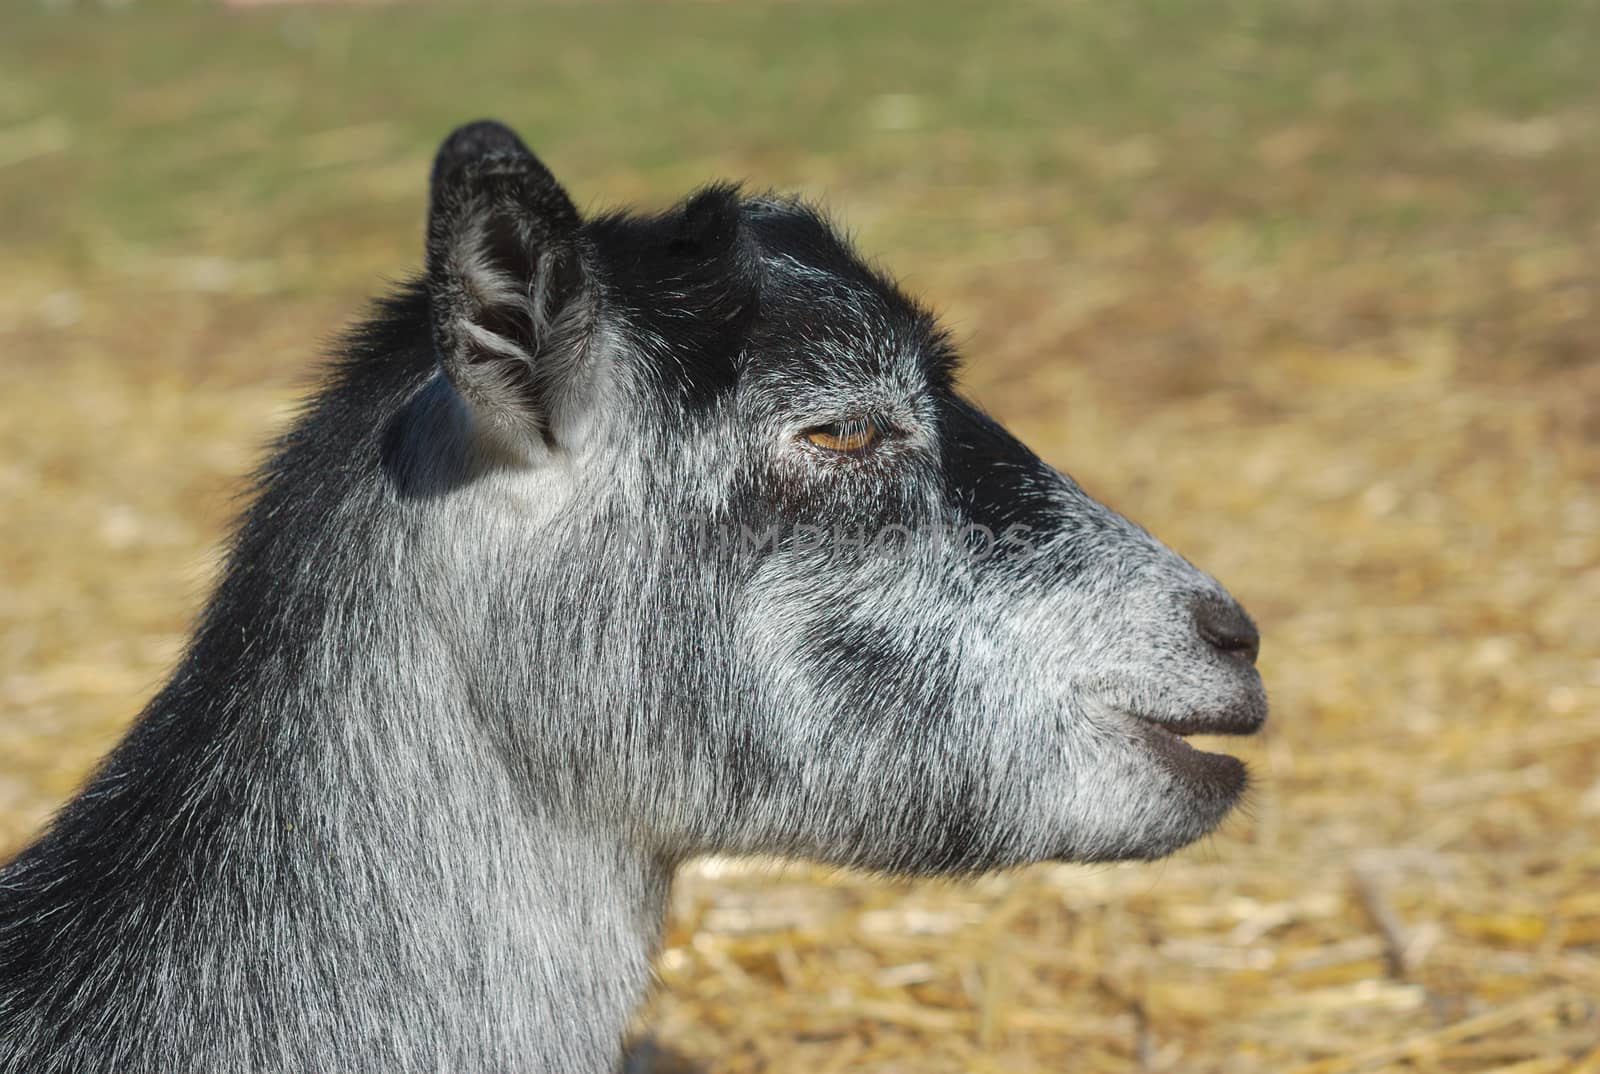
[590,187,950,402]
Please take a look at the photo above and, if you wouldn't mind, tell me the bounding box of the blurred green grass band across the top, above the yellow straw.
[0,0,1600,297]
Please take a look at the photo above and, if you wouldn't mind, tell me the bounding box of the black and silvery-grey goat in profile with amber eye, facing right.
[0,122,1266,1074]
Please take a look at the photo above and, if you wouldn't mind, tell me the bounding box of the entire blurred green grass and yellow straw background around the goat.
[0,0,1600,1074]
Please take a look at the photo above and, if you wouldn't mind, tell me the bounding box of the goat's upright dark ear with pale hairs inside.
[427,120,598,440]
